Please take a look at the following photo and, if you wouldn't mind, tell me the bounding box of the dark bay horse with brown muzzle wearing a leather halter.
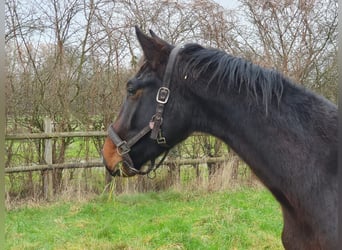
[102,28,338,250]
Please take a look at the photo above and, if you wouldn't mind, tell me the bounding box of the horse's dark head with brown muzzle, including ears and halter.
[102,27,192,176]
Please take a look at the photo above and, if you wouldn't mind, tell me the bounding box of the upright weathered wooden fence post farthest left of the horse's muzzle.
[43,117,53,200]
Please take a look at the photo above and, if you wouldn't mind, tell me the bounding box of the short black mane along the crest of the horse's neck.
[180,44,290,113]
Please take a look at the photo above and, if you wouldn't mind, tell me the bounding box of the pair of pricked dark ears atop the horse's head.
[135,26,172,68]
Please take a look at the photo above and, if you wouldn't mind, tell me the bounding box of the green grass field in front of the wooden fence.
[5,188,283,250]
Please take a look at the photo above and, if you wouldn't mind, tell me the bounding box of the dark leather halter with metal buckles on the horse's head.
[103,46,184,176]
